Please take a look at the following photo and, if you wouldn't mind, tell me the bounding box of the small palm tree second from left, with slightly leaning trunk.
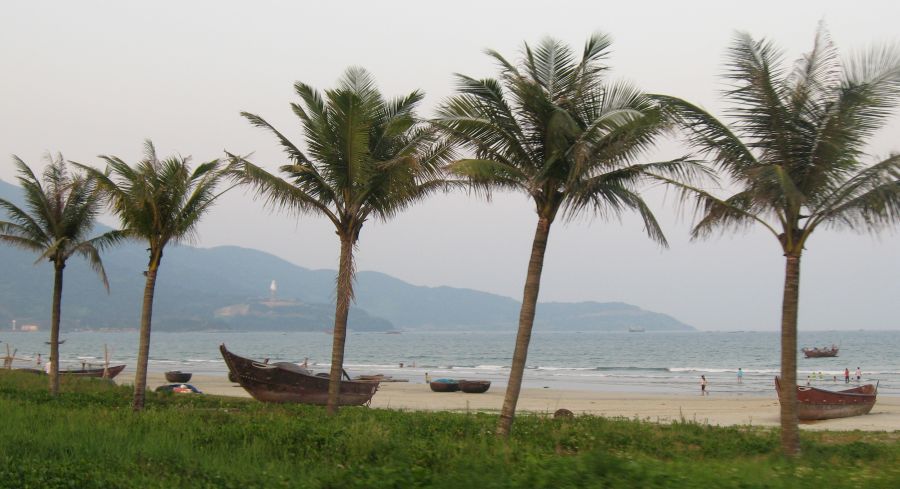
[79,140,228,411]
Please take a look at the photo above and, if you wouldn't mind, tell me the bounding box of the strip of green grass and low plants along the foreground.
[0,371,900,489]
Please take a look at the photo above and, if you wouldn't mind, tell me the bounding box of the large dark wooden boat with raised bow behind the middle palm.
[219,344,378,406]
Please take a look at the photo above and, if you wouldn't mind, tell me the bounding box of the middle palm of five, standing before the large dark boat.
[230,68,451,414]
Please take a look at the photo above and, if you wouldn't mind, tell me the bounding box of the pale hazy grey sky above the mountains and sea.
[0,0,900,330]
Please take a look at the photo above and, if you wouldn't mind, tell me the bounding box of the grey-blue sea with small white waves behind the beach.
[0,330,900,396]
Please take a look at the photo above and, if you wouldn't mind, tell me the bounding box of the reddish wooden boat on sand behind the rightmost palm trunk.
[775,377,878,420]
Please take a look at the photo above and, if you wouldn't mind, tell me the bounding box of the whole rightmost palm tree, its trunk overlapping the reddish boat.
[660,27,900,456]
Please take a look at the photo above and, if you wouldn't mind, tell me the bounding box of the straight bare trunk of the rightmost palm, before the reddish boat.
[780,254,800,457]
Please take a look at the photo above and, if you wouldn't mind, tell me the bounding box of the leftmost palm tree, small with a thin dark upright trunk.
[0,154,120,396]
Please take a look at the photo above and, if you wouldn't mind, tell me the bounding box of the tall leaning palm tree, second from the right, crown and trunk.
[435,34,698,436]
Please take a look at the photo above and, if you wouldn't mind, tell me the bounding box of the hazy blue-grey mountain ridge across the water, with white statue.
[0,181,693,331]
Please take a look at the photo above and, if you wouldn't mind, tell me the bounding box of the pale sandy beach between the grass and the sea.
[139,373,900,431]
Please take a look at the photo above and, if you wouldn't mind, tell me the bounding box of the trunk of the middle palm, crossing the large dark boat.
[328,234,353,415]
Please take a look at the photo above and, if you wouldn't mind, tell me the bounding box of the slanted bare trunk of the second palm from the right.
[497,217,551,437]
